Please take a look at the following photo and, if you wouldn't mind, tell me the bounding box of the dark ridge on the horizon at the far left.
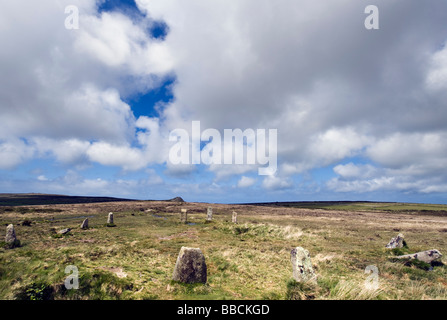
[0,193,135,206]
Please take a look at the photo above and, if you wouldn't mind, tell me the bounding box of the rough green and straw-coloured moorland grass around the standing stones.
[0,203,447,300]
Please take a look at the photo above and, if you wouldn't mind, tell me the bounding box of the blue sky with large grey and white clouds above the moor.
[0,0,447,204]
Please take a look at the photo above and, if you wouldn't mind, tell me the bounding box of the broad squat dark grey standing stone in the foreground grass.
[172,247,207,283]
